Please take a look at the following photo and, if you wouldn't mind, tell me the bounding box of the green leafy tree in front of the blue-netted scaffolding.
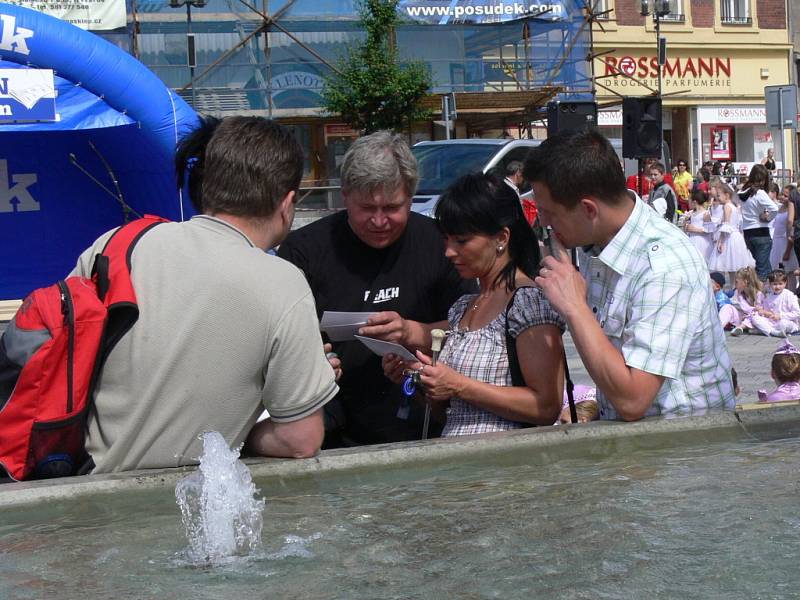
[322,0,431,133]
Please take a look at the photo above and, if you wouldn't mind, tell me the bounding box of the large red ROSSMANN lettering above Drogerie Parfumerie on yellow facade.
[602,56,731,93]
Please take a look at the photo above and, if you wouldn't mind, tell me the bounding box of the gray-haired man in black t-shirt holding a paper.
[278,131,475,448]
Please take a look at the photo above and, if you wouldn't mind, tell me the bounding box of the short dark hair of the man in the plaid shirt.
[524,129,630,208]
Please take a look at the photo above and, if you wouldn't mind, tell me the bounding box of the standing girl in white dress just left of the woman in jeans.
[708,181,756,287]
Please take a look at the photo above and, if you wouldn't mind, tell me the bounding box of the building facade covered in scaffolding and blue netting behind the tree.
[114,0,591,199]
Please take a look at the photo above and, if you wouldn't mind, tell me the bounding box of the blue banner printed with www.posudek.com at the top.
[398,0,567,25]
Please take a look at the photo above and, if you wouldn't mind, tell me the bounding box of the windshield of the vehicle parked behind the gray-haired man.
[411,144,498,196]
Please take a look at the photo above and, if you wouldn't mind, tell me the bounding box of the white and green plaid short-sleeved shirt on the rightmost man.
[581,201,735,419]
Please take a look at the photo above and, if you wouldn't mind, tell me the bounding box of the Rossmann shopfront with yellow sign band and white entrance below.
[594,48,792,172]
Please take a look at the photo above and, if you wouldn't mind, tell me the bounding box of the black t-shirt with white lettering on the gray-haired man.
[278,211,476,444]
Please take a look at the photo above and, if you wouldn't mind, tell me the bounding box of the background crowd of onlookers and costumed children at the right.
[628,150,800,402]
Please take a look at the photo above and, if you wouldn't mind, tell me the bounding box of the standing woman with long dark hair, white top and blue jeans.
[739,165,779,281]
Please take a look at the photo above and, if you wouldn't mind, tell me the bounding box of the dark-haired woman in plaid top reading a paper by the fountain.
[384,173,564,437]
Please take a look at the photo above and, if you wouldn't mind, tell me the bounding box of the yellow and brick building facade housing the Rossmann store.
[593,0,796,177]
